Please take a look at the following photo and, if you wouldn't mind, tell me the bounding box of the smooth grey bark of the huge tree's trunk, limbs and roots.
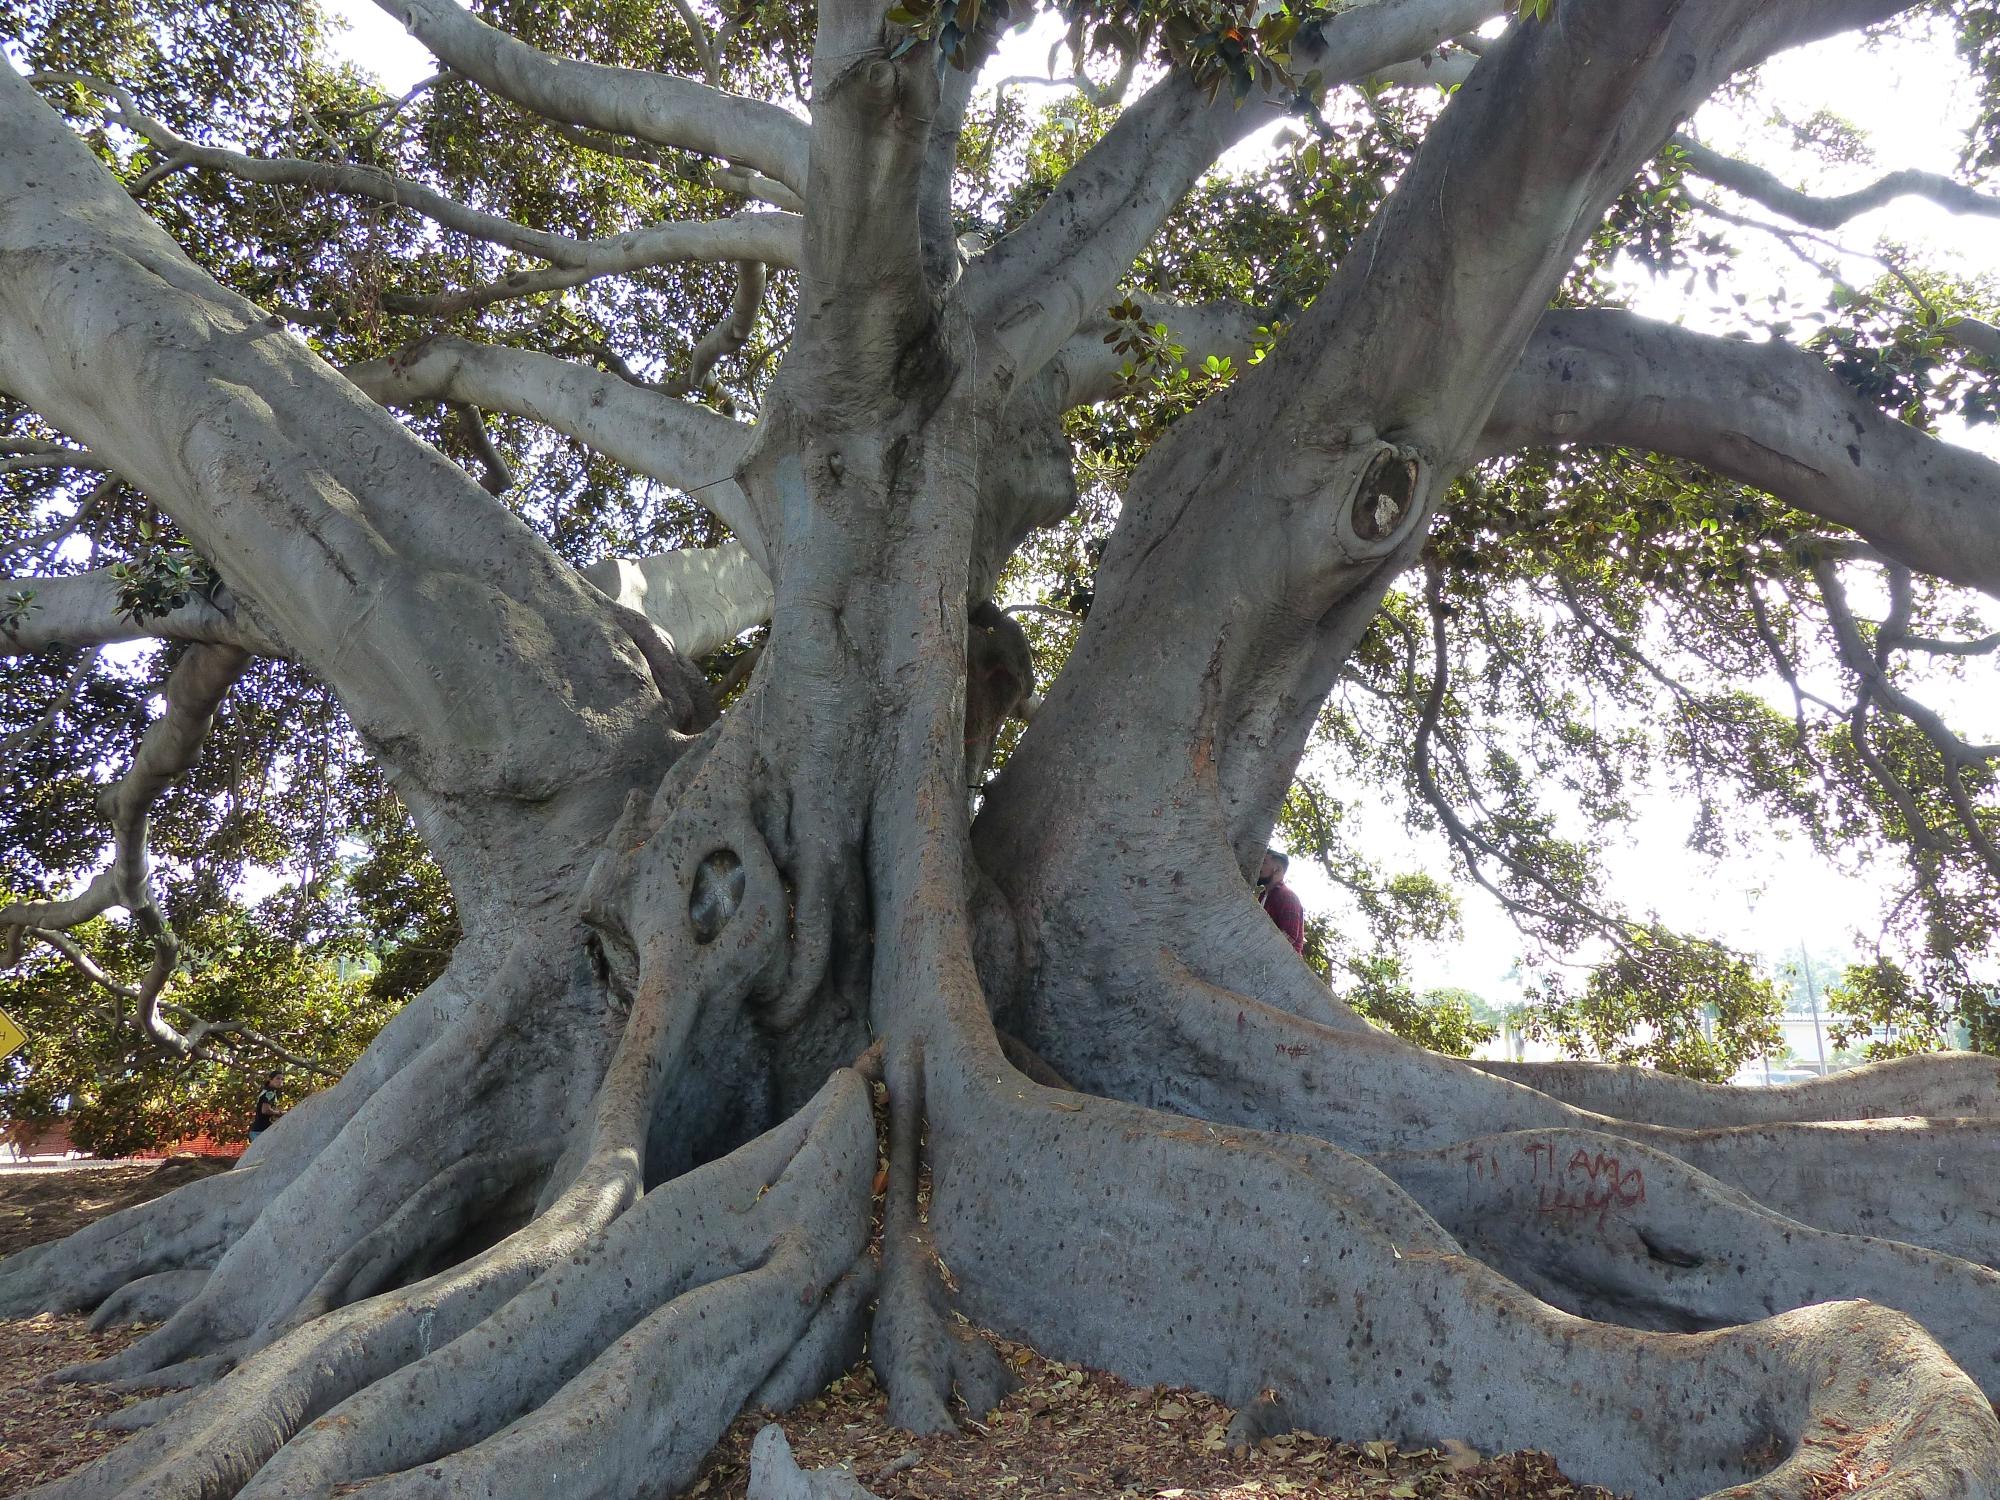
[0,0,2000,1500]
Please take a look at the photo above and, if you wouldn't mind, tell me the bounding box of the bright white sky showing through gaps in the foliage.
[320,0,2000,1002]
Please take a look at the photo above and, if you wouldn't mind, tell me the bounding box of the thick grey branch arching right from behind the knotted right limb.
[1480,310,2000,596]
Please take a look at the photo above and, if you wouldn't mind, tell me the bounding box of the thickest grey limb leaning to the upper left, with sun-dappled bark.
[0,68,668,902]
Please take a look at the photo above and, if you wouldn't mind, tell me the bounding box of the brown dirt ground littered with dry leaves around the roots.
[0,1158,1614,1500]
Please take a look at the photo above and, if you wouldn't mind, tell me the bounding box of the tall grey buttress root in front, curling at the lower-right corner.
[930,1016,2000,1500]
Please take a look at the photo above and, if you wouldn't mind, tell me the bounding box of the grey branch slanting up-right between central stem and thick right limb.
[966,0,1502,376]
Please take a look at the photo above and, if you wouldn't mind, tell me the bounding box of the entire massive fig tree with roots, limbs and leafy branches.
[0,0,2000,1500]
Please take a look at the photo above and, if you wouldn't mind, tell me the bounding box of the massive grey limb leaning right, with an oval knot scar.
[992,0,1896,880]
